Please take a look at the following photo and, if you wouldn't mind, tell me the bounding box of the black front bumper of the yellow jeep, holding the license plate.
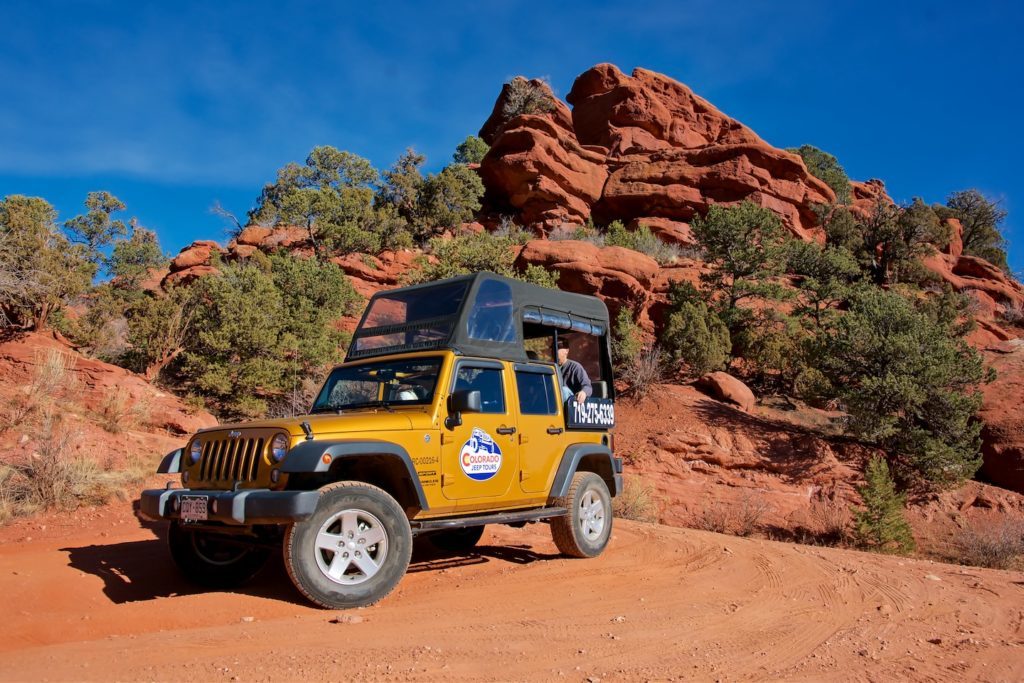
[139,488,319,524]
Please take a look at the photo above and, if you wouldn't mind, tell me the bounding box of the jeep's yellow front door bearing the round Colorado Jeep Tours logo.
[441,359,519,508]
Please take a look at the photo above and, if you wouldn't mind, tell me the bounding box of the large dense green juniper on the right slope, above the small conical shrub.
[814,286,989,484]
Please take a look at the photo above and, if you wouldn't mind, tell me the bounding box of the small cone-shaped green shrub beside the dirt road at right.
[854,457,915,555]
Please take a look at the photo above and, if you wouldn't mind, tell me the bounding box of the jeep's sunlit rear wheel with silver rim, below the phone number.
[551,472,611,557]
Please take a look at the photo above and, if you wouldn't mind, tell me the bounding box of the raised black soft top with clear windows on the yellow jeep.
[345,272,608,361]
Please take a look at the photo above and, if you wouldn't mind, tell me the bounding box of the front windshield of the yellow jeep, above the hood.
[311,357,441,413]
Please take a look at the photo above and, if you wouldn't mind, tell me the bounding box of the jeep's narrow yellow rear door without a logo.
[514,364,566,494]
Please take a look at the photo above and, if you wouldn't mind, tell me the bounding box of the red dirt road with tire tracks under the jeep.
[0,505,1024,681]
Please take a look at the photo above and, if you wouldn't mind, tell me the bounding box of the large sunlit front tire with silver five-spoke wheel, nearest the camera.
[284,481,413,609]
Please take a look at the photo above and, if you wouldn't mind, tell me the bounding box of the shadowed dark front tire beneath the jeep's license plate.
[167,520,270,589]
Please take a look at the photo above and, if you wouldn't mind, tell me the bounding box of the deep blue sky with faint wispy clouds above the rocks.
[0,0,1024,270]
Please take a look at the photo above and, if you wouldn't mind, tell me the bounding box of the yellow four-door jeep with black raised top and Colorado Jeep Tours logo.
[140,272,622,608]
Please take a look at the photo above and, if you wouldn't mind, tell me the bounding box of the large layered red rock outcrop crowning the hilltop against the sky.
[480,65,836,242]
